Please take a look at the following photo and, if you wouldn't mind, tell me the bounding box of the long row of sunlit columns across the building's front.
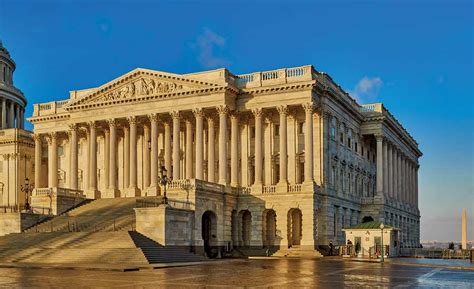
[31,103,314,196]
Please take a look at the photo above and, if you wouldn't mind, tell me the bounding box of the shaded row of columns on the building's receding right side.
[375,135,419,207]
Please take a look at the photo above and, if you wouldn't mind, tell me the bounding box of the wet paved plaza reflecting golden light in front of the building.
[0,259,474,288]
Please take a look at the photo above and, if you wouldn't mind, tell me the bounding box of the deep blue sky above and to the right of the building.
[0,0,474,240]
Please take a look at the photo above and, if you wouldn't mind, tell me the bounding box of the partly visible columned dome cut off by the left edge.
[0,40,26,129]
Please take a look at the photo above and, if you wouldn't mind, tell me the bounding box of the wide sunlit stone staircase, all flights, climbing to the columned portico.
[0,197,207,266]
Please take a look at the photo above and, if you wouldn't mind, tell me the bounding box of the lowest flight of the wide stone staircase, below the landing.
[0,231,148,265]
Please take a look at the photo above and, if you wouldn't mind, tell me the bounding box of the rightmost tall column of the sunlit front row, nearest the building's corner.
[303,103,314,183]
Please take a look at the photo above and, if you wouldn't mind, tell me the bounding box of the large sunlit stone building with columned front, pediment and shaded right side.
[29,66,421,249]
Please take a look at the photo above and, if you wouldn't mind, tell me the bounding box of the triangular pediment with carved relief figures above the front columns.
[64,68,221,110]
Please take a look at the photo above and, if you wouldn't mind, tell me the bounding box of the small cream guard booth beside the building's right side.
[340,221,400,258]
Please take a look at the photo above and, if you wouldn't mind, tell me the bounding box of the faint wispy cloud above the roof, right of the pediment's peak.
[192,28,229,68]
